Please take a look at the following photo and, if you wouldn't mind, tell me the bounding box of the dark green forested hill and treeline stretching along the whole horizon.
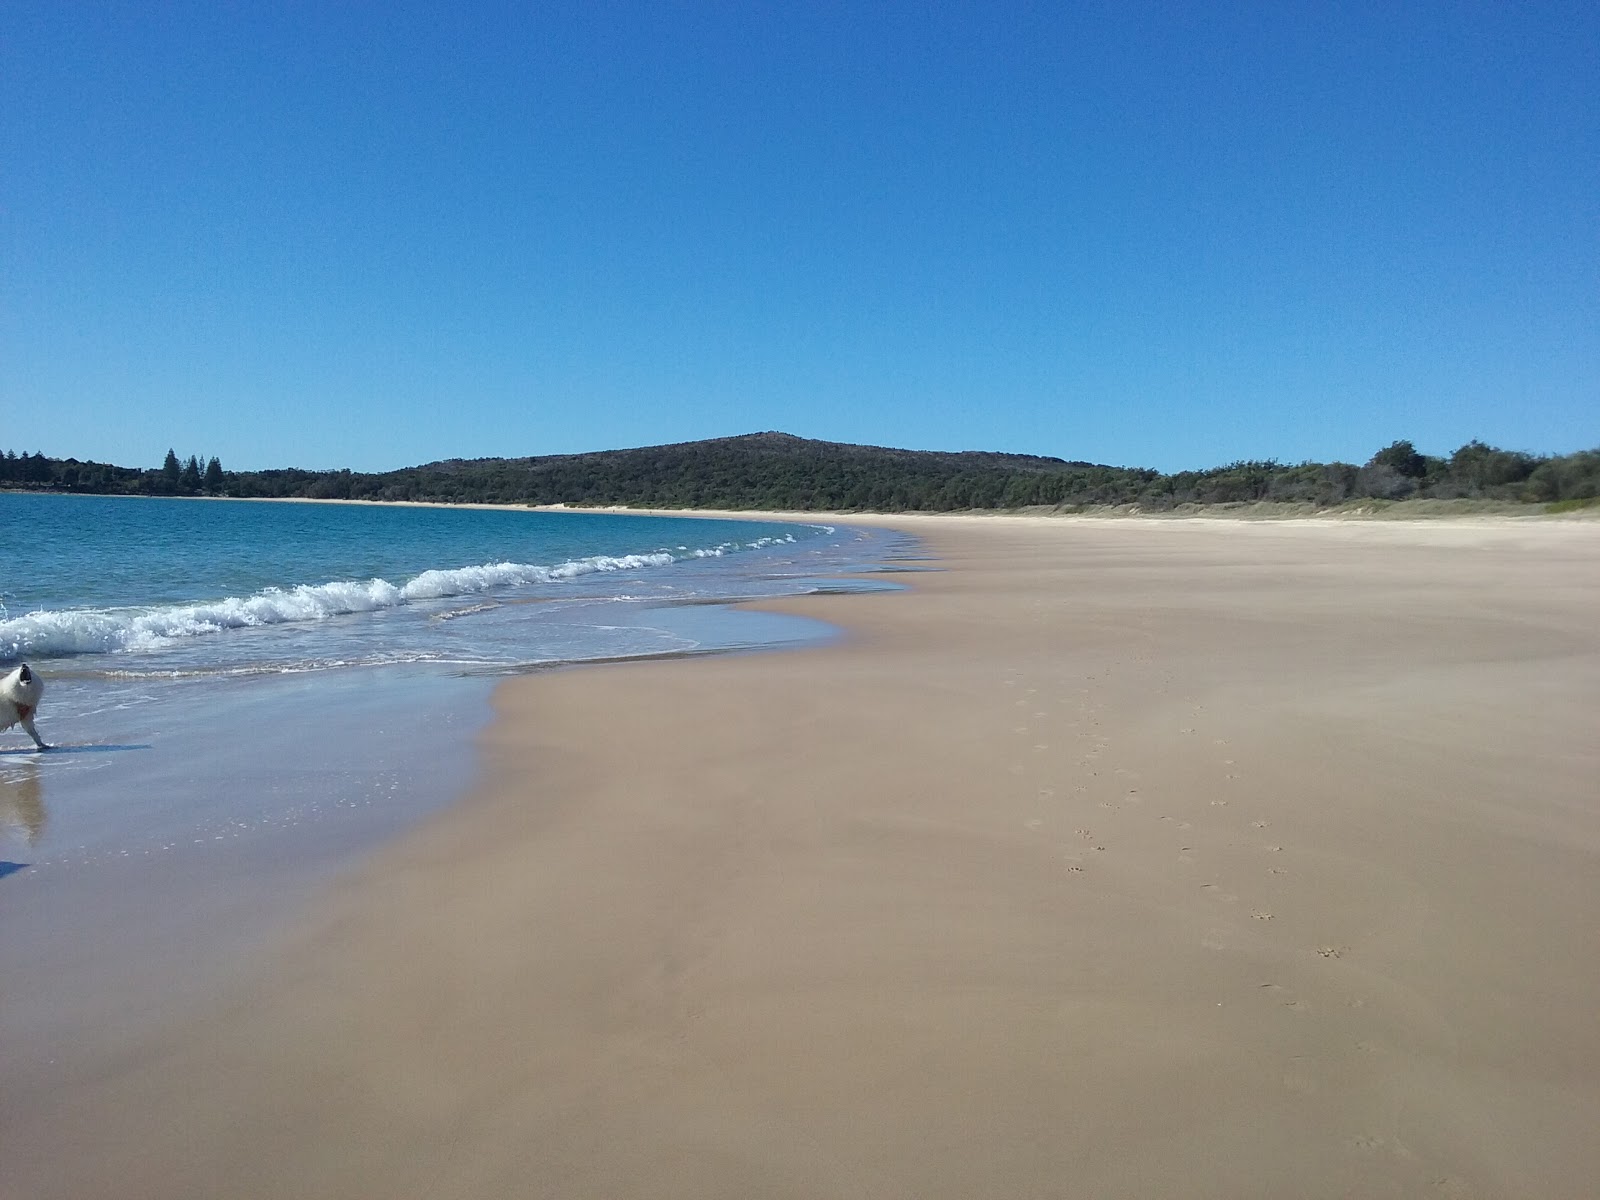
[0,434,1600,512]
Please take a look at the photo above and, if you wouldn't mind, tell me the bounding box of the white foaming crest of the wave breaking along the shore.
[0,538,794,658]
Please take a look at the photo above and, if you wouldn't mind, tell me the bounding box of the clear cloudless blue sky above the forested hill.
[0,0,1600,470]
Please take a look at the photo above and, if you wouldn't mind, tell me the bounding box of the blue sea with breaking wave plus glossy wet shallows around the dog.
[0,493,917,1074]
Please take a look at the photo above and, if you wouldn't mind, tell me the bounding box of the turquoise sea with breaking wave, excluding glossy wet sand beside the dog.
[0,493,864,675]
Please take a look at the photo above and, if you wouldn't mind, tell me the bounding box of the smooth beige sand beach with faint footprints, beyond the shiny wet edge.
[0,518,1600,1200]
